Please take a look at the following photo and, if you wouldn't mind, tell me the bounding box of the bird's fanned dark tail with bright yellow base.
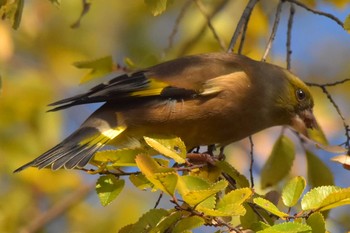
[14,107,126,172]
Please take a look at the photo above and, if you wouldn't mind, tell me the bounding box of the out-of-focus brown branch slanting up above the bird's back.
[178,0,229,57]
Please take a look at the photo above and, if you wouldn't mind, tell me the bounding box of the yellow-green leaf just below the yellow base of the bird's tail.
[91,149,144,167]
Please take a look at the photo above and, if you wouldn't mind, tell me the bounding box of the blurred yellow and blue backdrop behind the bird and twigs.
[0,0,350,233]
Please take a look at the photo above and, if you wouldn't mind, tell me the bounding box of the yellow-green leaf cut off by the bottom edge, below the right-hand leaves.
[257,222,311,233]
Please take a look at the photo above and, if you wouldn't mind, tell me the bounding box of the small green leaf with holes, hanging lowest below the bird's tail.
[96,175,125,206]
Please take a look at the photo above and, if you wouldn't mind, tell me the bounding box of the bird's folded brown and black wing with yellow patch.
[50,53,247,111]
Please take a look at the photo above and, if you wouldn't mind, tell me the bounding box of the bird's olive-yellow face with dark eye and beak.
[278,70,317,132]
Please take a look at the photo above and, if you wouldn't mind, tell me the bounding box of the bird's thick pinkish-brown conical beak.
[291,109,318,135]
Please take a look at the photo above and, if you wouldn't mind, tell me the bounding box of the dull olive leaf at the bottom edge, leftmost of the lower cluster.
[129,209,169,233]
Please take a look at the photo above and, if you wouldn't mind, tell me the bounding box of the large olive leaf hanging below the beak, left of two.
[261,135,295,189]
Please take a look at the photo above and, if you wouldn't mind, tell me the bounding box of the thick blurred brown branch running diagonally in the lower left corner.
[20,184,95,233]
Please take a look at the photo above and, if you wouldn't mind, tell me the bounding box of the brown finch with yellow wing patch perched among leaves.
[14,52,317,172]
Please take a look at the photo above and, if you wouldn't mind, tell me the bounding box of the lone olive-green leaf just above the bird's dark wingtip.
[73,56,114,83]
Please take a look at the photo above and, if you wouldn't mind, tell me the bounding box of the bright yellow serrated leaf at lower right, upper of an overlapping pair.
[301,186,341,210]
